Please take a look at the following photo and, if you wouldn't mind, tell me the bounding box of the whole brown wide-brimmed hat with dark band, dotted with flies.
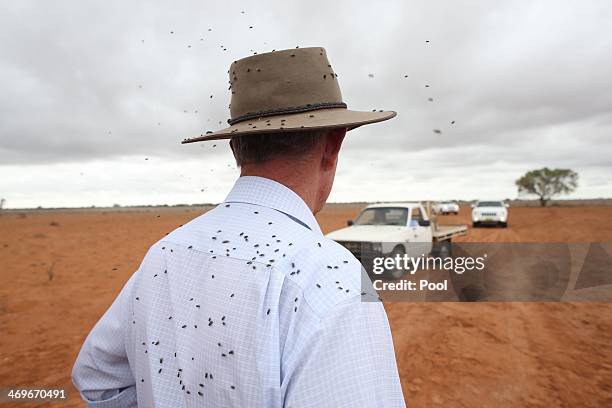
[183,47,396,143]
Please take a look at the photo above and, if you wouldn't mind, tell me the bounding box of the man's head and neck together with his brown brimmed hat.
[183,47,395,213]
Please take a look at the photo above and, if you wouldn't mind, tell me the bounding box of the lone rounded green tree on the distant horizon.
[516,167,578,207]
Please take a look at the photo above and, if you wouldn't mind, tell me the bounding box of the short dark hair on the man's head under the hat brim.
[230,129,329,167]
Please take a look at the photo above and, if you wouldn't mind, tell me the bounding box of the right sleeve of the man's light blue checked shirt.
[284,298,406,408]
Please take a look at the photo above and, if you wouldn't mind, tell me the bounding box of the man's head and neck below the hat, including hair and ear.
[230,128,346,214]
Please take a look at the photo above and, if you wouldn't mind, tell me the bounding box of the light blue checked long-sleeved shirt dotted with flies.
[72,177,405,408]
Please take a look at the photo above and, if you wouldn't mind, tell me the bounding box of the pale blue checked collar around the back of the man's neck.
[224,176,322,234]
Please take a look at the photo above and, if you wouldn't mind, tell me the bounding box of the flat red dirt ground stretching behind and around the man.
[0,205,612,407]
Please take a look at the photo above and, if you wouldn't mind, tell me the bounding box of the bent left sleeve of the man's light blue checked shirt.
[72,274,137,407]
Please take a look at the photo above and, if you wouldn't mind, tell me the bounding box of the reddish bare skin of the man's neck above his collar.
[240,161,320,214]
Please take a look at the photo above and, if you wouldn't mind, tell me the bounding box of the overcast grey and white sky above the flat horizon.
[0,0,612,208]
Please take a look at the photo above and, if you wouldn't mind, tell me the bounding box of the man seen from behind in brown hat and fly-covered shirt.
[73,48,405,407]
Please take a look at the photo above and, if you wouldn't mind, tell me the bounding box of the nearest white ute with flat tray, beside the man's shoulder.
[327,203,467,278]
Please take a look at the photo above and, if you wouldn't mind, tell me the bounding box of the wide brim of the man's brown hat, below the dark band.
[182,108,397,143]
